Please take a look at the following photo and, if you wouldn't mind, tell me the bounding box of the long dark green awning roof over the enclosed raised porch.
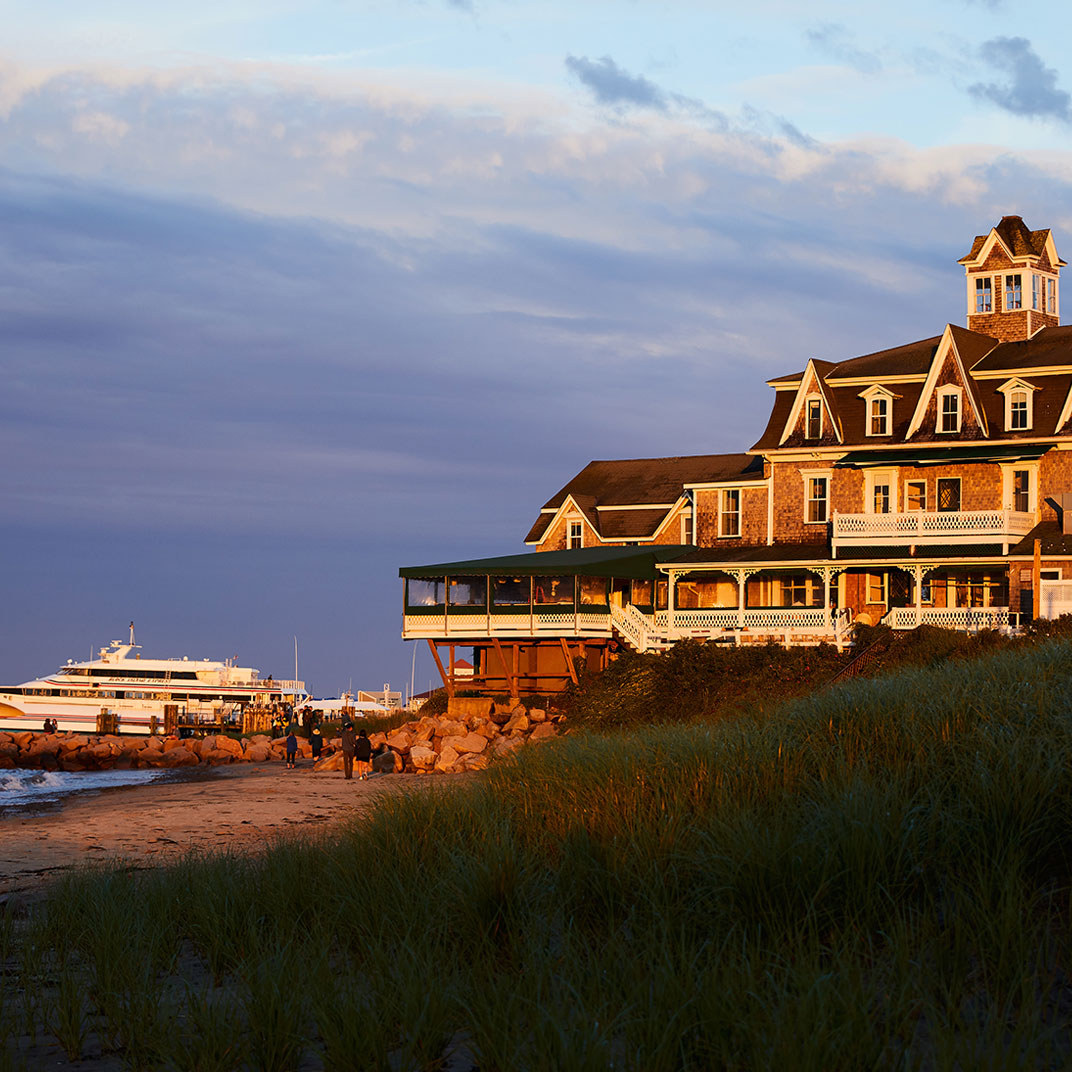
[399,545,696,580]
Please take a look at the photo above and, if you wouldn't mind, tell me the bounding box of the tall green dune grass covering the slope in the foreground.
[6,640,1072,1072]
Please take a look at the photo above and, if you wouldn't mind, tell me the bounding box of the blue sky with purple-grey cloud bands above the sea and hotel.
[0,0,1072,696]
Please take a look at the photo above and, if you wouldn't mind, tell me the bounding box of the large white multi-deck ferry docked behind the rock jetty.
[0,625,308,733]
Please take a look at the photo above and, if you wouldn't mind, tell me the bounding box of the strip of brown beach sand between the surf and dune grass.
[0,763,430,897]
